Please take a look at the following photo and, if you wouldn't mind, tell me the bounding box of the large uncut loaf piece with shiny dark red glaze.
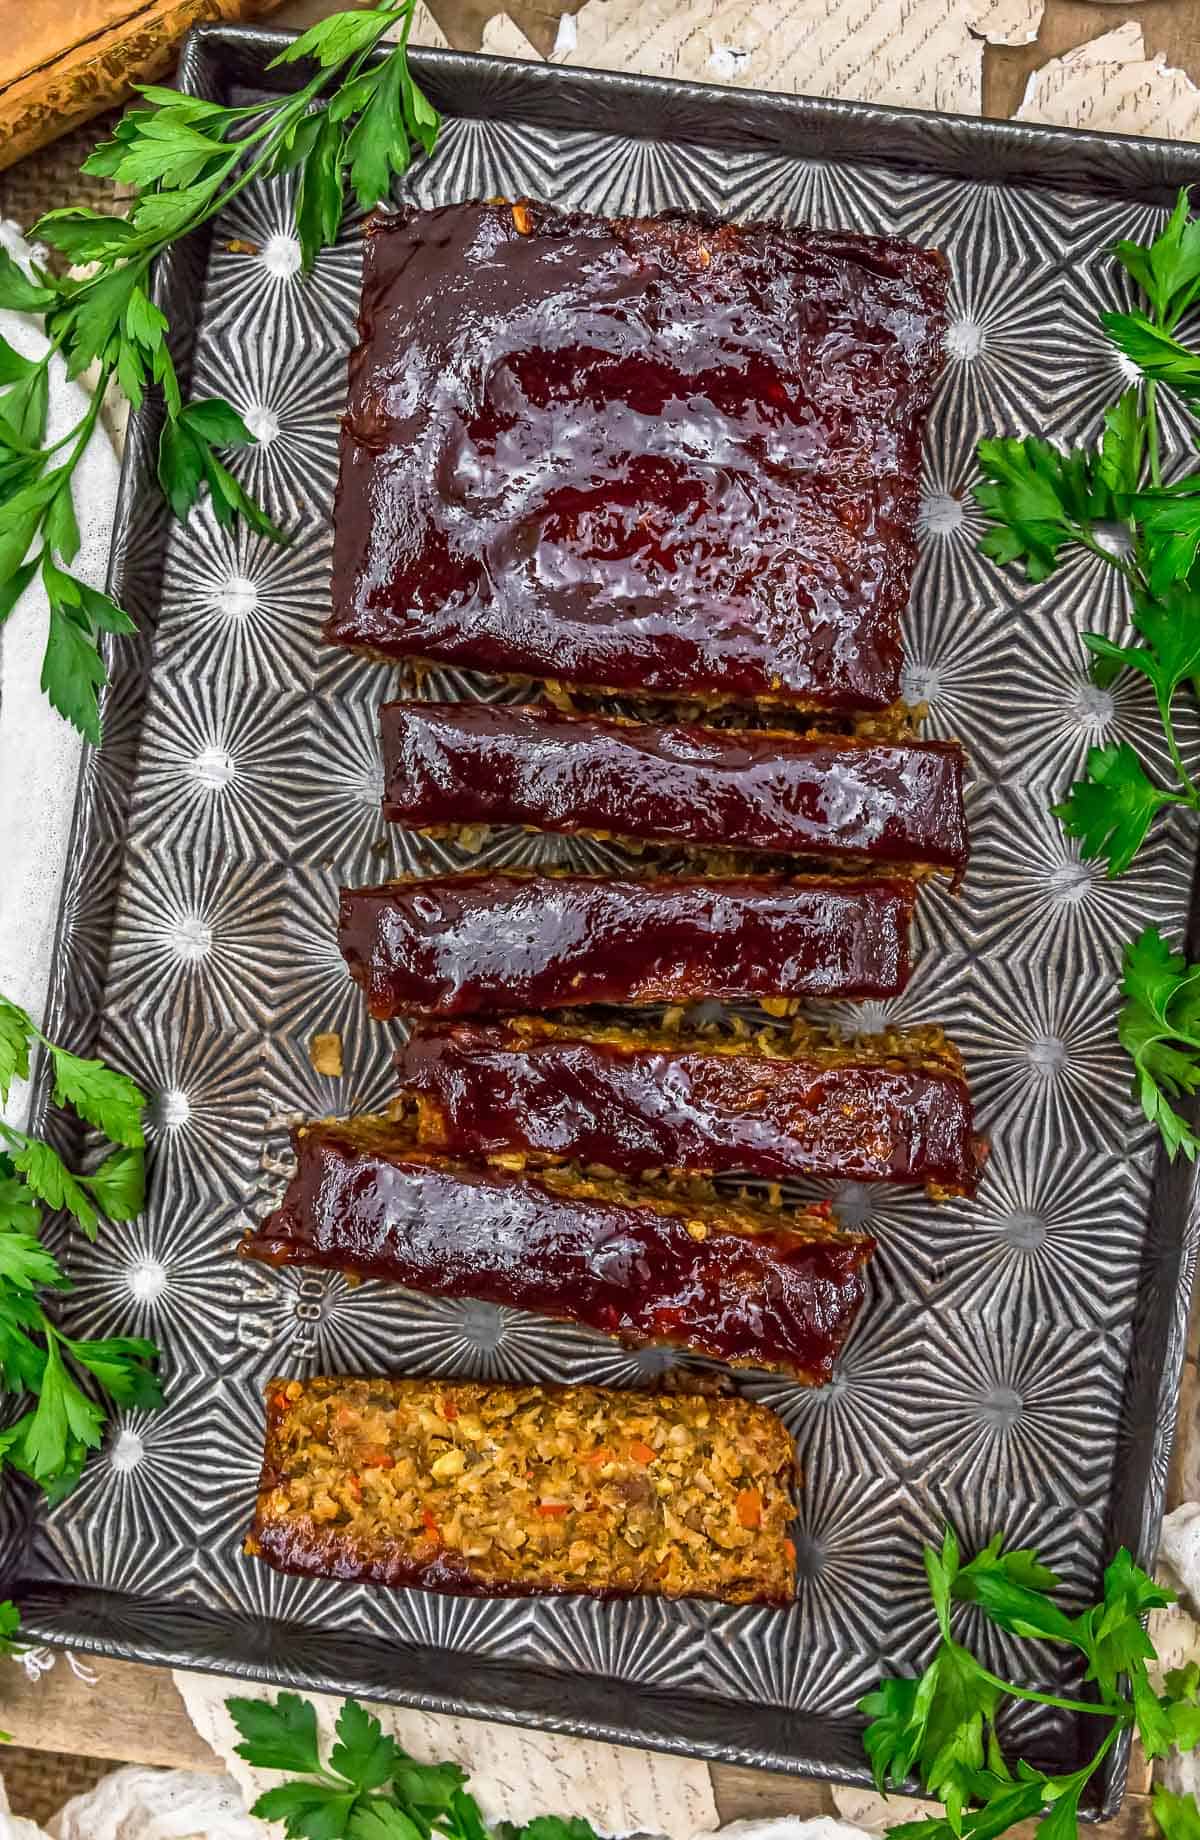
[326,202,946,708]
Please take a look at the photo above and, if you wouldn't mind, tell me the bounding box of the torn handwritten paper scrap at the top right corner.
[1016,20,1200,140]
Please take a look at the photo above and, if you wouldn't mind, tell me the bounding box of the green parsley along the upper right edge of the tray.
[975,191,1200,1159]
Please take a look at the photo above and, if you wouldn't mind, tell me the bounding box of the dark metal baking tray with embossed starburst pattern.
[9,28,1200,1809]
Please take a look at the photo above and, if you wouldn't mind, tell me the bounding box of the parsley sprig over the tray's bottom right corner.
[860,1531,1200,1840]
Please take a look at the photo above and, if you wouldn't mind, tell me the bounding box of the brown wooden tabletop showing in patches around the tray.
[0,0,1200,1817]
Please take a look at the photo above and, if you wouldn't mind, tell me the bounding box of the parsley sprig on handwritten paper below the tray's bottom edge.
[225,1693,596,1840]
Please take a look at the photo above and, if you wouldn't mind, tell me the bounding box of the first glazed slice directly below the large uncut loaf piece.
[379,703,966,874]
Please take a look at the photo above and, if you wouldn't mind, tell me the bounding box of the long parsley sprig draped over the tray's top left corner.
[0,0,438,745]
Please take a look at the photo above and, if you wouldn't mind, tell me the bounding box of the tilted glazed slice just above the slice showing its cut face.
[241,1119,872,1386]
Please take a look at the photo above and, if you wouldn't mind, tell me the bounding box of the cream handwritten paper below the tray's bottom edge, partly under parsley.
[173,1673,718,1840]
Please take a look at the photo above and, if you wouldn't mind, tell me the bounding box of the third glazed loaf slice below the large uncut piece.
[396,1016,977,1194]
